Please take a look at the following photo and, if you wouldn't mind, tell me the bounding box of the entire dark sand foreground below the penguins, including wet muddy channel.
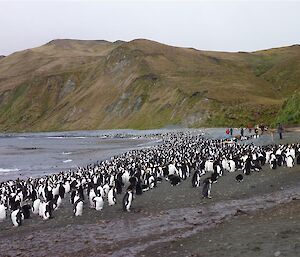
[0,161,300,257]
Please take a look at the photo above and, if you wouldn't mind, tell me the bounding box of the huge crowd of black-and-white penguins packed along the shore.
[0,132,300,227]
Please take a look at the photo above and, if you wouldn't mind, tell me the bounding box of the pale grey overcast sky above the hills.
[0,0,300,55]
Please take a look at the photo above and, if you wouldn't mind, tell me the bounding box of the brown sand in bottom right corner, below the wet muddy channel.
[140,198,300,257]
